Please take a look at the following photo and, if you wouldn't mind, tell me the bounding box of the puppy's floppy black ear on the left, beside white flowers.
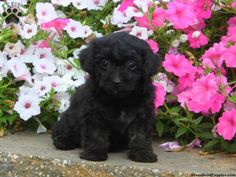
[79,45,93,74]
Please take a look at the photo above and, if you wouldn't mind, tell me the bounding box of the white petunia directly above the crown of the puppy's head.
[111,6,131,27]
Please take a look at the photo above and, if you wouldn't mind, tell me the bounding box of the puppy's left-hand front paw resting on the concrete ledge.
[80,151,108,161]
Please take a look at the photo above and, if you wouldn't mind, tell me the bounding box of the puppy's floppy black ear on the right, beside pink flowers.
[144,48,161,77]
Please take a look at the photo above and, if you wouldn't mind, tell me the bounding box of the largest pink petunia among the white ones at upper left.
[40,18,70,34]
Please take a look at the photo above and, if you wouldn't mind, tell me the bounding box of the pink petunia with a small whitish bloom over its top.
[188,31,208,48]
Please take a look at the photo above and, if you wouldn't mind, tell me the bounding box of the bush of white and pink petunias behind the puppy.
[0,0,236,152]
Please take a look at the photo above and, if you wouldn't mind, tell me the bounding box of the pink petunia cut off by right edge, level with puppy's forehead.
[223,45,236,68]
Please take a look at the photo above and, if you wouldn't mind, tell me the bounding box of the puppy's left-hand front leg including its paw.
[80,125,109,161]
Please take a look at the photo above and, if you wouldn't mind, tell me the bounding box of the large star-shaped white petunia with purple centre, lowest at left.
[14,94,40,121]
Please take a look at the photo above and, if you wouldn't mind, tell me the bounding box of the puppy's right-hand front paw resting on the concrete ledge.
[128,151,157,162]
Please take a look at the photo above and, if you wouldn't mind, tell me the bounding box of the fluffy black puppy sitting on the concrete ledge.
[52,32,160,162]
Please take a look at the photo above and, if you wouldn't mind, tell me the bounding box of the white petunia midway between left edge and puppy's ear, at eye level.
[33,59,56,74]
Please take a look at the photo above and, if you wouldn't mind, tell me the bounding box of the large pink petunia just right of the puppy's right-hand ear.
[163,54,196,77]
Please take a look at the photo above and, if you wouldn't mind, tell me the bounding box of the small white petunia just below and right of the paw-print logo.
[20,23,37,39]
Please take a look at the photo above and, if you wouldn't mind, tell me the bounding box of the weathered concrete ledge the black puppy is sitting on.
[0,132,236,177]
